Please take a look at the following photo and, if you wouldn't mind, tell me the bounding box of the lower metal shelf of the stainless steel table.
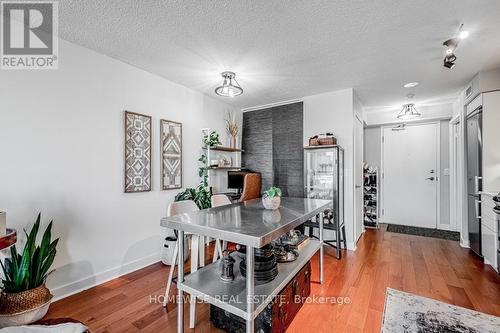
[181,239,320,320]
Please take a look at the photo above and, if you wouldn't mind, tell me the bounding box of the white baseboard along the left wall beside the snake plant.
[50,252,160,302]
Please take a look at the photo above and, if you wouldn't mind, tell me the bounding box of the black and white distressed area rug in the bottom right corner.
[382,288,500,333]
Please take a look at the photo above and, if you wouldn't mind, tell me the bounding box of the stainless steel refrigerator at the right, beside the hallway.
[466,106,483,257]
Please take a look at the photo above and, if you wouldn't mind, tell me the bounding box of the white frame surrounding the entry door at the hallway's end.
[379,120,442,230]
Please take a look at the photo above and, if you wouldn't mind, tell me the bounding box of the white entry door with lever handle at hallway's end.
[382,123,439,228]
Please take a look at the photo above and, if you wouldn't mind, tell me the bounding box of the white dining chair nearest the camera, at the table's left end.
[163,200,205,328]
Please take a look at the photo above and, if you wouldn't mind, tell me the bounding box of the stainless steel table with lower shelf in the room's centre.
[161,197,331,333]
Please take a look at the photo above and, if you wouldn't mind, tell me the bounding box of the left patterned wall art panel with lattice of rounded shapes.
[125,111,152,193]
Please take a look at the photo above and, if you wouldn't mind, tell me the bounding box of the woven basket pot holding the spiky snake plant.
[0,284,52,328]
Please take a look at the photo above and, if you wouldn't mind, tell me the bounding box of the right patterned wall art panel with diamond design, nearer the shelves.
[160,119,182,190]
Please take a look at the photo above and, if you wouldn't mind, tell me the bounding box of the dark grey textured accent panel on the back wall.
[242,102,304,197]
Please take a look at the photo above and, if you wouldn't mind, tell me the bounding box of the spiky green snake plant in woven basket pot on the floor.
[0,214,59,327]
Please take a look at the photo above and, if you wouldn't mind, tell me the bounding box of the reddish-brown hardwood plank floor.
[47,227,500,333]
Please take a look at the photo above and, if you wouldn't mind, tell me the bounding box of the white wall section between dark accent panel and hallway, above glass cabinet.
[304,88,355,250]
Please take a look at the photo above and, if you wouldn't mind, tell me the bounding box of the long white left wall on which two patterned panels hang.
[0,40,238,297]
